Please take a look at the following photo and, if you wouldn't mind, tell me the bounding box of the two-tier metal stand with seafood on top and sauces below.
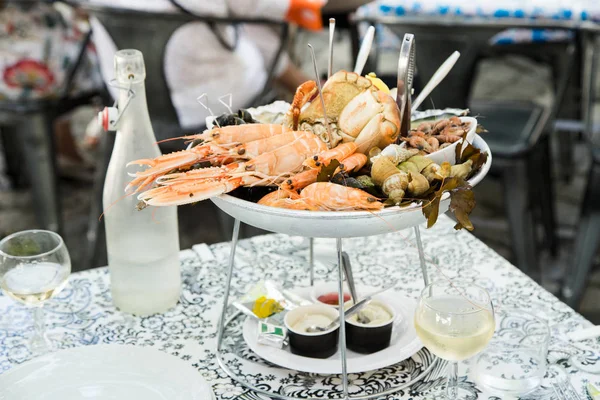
[126,30,492,399]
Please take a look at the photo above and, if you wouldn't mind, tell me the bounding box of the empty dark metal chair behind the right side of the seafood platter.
[370,21,574,275]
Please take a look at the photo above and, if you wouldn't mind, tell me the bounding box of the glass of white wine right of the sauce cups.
[415,280,496,400]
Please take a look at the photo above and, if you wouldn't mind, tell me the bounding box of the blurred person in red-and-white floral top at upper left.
[0,1,100,101]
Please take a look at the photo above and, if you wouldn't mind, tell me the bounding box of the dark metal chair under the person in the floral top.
[0,28,99,232]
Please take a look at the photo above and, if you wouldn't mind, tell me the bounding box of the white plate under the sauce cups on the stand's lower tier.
[243,287,423,374]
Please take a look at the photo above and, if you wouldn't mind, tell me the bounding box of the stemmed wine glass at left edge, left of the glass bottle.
[0,230,71,355]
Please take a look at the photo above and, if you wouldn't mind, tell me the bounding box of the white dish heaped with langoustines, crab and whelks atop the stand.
[127,70,491,237]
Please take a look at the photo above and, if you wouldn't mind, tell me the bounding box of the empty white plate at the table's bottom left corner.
[0,345,214,400]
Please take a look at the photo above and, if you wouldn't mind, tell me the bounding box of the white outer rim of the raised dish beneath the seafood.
[211,135,492,238]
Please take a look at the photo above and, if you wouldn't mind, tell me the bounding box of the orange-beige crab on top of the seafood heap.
[286,70,400,154]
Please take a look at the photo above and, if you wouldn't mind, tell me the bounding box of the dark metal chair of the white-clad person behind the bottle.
[82,5,288,266]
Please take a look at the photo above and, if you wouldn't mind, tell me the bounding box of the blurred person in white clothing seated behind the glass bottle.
[89,0,325,130]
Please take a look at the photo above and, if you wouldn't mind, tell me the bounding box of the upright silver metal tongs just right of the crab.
[396,33,416,137]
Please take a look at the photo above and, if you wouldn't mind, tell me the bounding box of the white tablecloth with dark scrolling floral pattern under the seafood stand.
[0,216,600,400]
